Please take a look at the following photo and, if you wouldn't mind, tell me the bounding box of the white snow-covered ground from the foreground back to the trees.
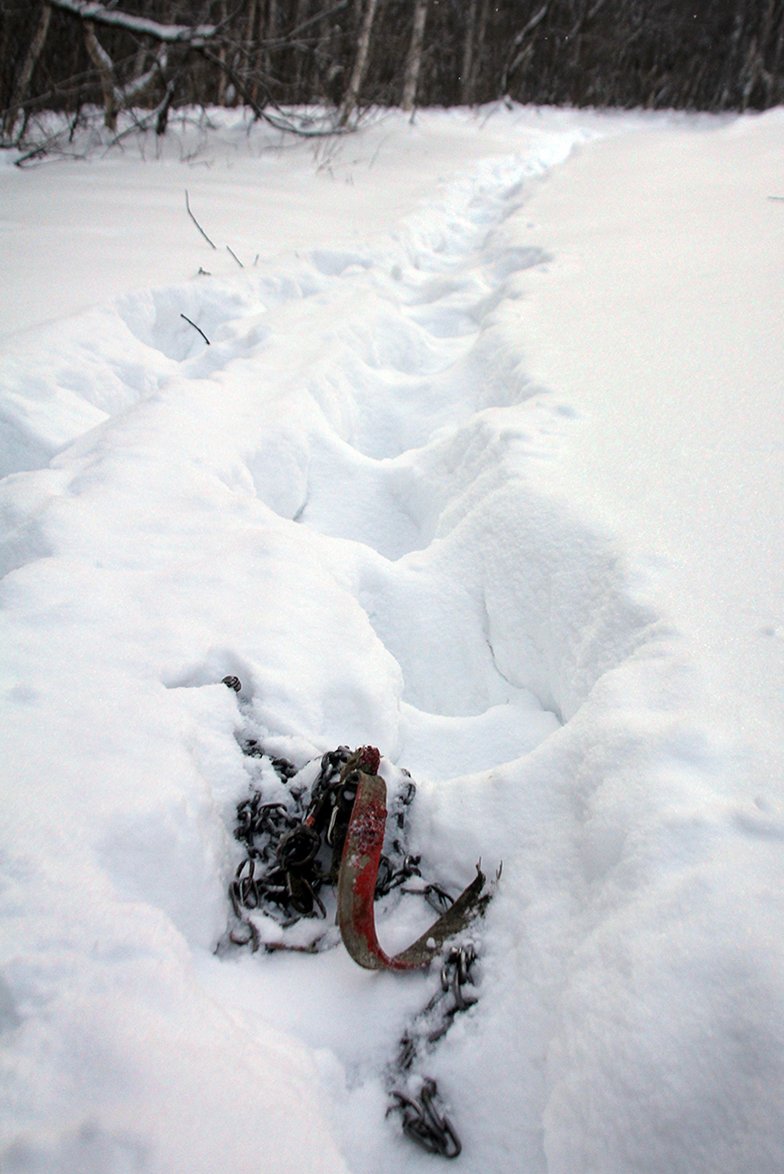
[0,108,784,1174]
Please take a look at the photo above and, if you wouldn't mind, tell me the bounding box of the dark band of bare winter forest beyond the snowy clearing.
[0,0,784,143]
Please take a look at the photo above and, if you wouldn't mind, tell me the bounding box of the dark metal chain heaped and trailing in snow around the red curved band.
[223,677,477,1159]
